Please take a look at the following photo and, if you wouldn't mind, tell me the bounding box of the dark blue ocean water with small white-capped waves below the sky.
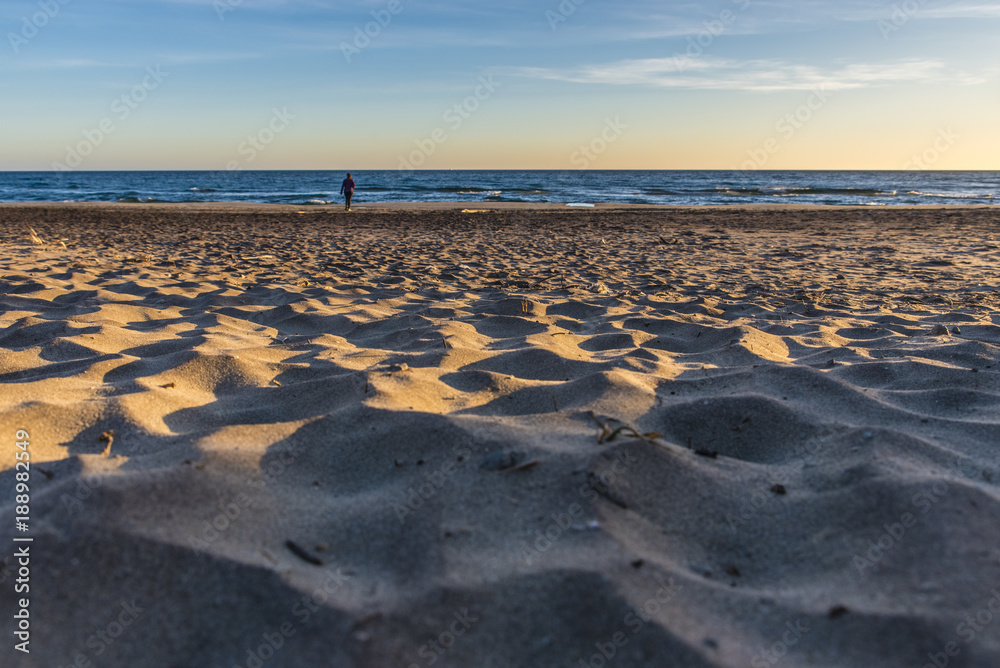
[0,170,1000,206]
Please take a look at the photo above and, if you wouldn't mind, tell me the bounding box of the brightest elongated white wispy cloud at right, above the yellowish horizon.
[505,57,986,91]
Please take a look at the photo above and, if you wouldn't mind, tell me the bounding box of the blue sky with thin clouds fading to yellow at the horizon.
[0,0,1000,170]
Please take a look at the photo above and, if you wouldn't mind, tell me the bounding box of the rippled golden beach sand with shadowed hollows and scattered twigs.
[0,204,1000,668]
